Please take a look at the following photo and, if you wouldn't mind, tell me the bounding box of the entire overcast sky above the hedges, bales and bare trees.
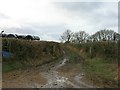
[0,0,118,41]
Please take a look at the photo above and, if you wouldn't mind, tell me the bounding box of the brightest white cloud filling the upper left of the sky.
[0,0,69,25]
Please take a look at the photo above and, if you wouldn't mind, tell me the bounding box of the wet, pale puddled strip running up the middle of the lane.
[36,57,94,88]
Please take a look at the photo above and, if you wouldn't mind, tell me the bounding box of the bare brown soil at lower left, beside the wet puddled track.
[2,68,47,88]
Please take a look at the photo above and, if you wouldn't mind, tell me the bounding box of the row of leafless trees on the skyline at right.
[61,29,120,43]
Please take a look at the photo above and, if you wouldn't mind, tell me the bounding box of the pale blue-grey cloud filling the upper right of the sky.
[56,2,118,31]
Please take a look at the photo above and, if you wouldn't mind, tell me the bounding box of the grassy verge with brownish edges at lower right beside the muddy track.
[84,58,118,88]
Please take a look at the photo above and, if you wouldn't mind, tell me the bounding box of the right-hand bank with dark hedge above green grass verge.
[63,42,118,87]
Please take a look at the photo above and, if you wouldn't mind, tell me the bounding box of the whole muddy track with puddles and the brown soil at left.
[3,57,95,88]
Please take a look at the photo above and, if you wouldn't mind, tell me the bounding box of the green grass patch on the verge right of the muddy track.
[84,58,117,85]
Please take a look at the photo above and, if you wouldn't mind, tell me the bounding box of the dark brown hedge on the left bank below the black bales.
[2,38,63,65]
